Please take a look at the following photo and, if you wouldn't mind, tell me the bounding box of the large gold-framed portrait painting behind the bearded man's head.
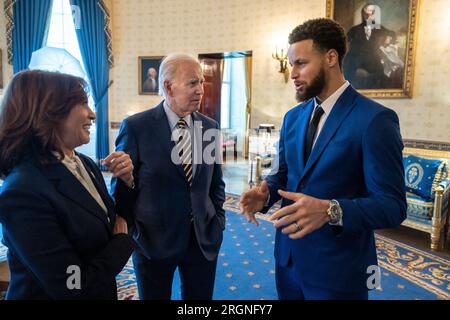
[326,0,419,98]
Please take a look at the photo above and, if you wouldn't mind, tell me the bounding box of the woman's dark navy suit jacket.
[0,154,132,299]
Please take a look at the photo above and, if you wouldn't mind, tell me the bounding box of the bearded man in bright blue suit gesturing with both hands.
[241,18,406,299]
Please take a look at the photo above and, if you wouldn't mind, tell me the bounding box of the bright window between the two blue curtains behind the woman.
[45,0,96,159]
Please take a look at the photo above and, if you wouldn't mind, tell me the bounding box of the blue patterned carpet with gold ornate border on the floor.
[0,195,450,300]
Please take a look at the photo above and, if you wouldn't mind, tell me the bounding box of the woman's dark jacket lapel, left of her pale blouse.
[44,162,110,230]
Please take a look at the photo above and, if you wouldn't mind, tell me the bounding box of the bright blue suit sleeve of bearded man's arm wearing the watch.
[337,110,406,233]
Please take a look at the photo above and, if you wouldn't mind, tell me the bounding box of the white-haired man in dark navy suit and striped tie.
[112,54,225,300]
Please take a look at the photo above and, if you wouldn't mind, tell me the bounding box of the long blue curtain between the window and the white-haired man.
[70,0,109,162]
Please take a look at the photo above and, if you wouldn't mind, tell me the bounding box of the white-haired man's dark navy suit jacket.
[112,102,225,260]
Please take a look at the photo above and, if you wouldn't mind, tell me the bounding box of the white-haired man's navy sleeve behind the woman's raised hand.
[111,119,139,223]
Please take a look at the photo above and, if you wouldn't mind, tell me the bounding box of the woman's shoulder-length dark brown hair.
[0,70,88,176]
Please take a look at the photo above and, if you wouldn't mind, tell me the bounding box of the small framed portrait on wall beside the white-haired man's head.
[138,56,164,95]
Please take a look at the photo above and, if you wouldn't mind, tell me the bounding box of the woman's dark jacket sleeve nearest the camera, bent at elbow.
[0,189,133,299]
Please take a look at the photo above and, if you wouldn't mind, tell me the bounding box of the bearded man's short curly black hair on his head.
[289,18,347,69]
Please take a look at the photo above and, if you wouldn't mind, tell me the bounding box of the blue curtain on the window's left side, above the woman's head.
[12,0,52,73]
